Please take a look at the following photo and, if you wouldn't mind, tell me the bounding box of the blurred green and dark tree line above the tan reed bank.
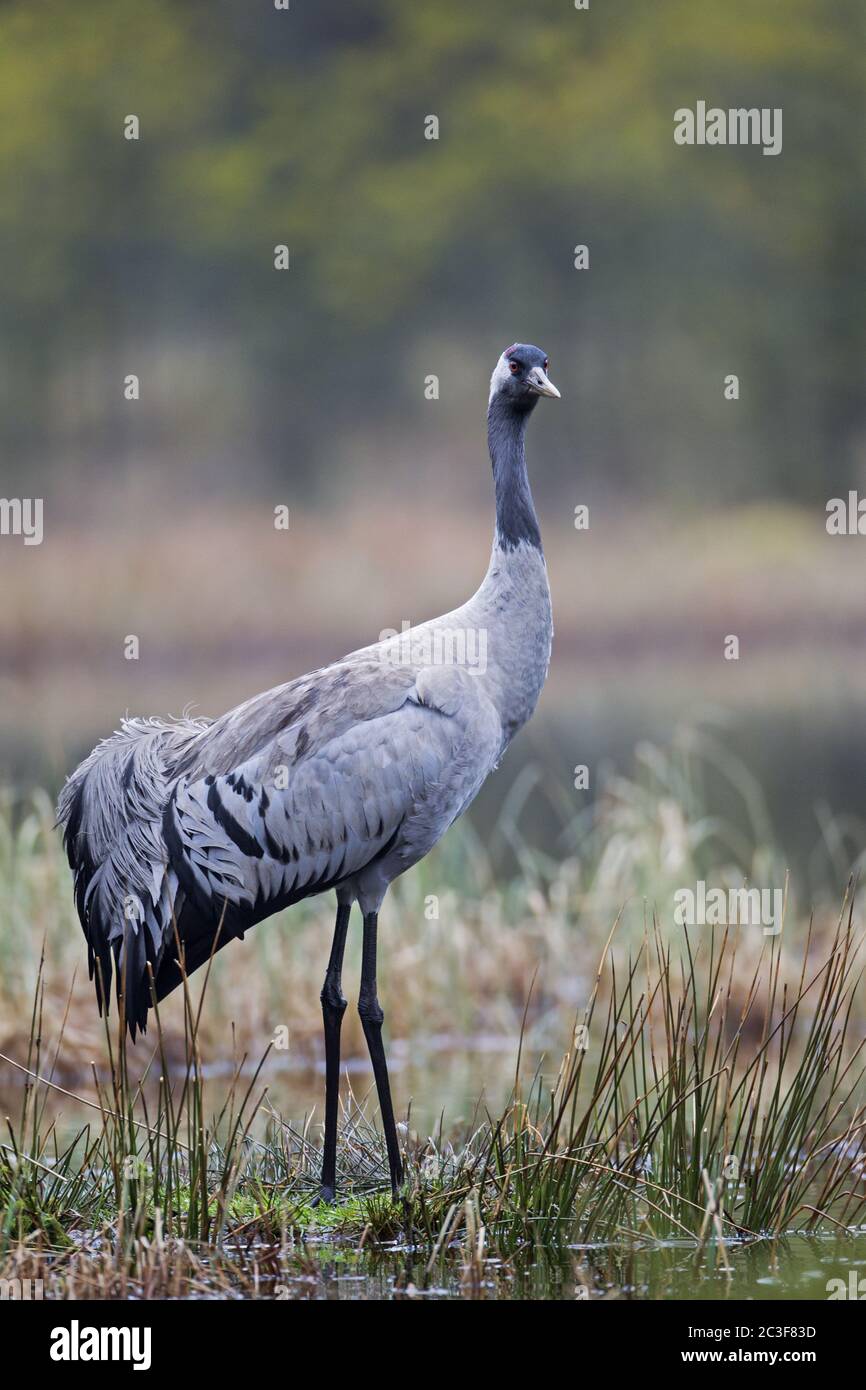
[0,0,866,505]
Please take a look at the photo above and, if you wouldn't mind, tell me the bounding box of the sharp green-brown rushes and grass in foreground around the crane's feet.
[0,888,866,1297]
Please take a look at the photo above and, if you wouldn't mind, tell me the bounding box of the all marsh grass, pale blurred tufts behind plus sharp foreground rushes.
[0,730,866,1298]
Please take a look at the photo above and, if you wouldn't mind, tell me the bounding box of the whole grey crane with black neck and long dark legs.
[57,343,559,1201]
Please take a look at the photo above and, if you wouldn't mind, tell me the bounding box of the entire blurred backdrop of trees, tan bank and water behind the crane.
[0,0,866,891]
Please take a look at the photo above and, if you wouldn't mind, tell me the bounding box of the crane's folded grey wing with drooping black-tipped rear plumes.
[58,653,502,1036]
